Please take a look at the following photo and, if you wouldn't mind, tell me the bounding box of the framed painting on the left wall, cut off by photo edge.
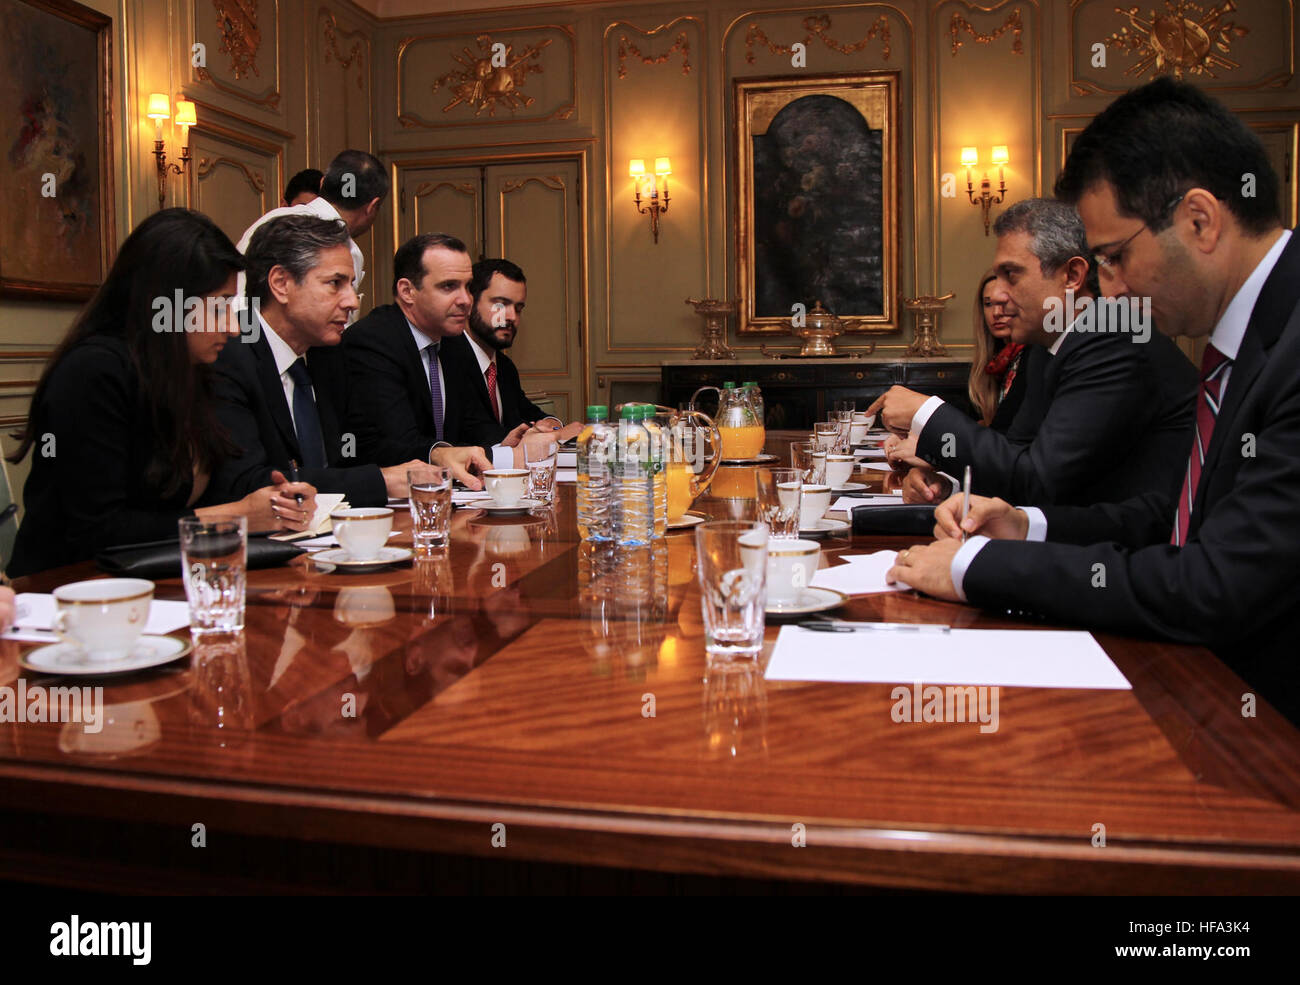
[0,0,116,300]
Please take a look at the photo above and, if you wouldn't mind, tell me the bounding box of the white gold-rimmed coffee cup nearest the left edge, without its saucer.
[53,578,153,660]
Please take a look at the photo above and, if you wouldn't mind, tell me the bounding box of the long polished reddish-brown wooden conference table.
[0,434,1300,894]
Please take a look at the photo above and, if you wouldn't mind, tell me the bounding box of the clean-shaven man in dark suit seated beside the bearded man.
[343,233,538,468]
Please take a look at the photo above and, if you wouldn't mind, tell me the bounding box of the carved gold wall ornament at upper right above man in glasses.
[1106,0,1251,79]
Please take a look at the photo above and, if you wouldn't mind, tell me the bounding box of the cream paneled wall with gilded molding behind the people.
[0,0,1300,519]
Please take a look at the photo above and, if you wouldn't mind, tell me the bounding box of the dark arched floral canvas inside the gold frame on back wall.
[753,95,884,318]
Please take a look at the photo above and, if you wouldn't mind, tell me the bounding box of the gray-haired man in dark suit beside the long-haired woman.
[212,216,488,505]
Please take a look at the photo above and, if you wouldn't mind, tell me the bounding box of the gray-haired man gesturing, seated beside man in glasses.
[868,199,1196,504]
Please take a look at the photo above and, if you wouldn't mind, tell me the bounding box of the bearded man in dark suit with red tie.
[441,259,582,441]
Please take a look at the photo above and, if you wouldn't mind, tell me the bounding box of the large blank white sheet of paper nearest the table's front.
[767,628,1132,690]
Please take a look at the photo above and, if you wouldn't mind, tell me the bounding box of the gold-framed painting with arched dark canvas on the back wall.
[733,71,901,335]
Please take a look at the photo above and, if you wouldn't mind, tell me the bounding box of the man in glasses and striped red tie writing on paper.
[891,78,1300,721]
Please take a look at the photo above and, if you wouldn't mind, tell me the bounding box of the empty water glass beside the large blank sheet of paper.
[696,520,767,660]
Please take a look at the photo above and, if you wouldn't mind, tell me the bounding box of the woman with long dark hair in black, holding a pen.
[9,209,316,576]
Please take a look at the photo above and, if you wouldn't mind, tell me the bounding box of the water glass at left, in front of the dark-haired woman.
[179,516,248,634]
